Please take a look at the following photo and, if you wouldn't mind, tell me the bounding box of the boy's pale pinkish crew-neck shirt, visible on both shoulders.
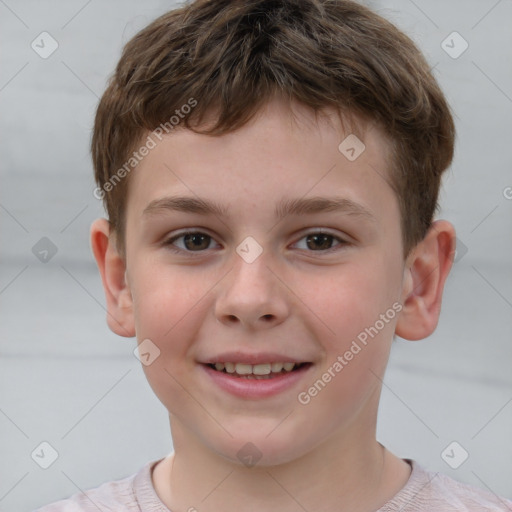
[35,459,512,512]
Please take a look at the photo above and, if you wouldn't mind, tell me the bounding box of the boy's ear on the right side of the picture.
[395,220,455,340]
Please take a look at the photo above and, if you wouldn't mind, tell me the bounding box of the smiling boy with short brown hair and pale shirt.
[40,0,512,512]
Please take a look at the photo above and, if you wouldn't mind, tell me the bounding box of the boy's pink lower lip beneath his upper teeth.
[200,364,312,398]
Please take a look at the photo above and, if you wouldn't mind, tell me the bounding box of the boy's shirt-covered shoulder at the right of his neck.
[379,461,512,512]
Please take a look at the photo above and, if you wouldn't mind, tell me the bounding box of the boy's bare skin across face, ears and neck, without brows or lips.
[91,99,455,512]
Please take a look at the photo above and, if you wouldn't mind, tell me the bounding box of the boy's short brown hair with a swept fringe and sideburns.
[91,0,455,255]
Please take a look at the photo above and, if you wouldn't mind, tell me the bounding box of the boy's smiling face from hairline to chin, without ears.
[115,101,410,464]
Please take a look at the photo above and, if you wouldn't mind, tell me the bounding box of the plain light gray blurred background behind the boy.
[0,0,512,511]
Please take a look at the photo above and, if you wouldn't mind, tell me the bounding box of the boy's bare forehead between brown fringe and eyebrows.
[128,100,392,226]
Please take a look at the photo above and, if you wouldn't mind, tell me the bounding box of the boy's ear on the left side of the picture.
[91,219,135,338]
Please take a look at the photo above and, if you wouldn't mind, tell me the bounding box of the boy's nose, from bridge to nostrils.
[215,256,289,330]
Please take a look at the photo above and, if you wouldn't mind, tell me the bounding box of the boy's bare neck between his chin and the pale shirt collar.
[153,418,410,512]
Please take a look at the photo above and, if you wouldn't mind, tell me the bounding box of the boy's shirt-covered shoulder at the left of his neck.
[34,461,162,512]
